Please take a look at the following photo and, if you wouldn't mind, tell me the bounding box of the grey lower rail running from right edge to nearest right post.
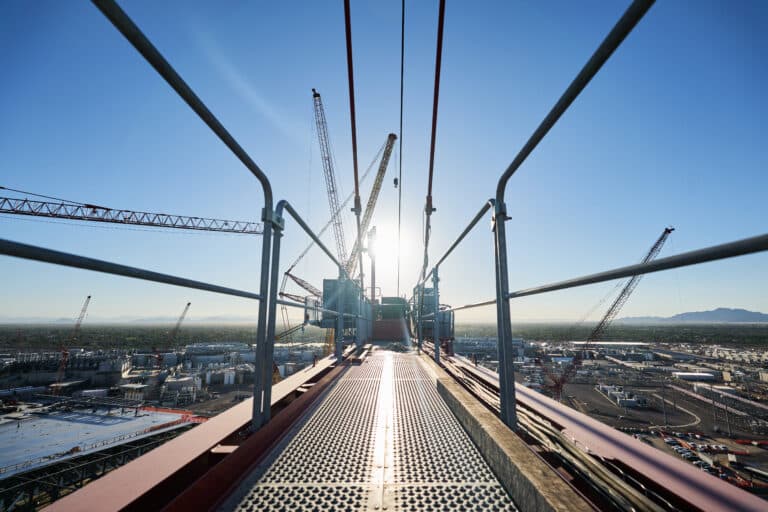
[507,233,768,299]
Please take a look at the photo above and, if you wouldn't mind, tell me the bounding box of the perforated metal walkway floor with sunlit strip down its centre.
[223,350,516,512]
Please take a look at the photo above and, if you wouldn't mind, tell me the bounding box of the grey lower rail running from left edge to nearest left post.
[0,238,262,300]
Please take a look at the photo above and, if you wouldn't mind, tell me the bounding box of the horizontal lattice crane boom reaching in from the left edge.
[0,197,264,235]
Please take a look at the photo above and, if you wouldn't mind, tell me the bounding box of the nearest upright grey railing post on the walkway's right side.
[493,200,517,429]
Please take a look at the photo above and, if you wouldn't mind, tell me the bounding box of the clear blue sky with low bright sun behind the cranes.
[0,1,768,321]
